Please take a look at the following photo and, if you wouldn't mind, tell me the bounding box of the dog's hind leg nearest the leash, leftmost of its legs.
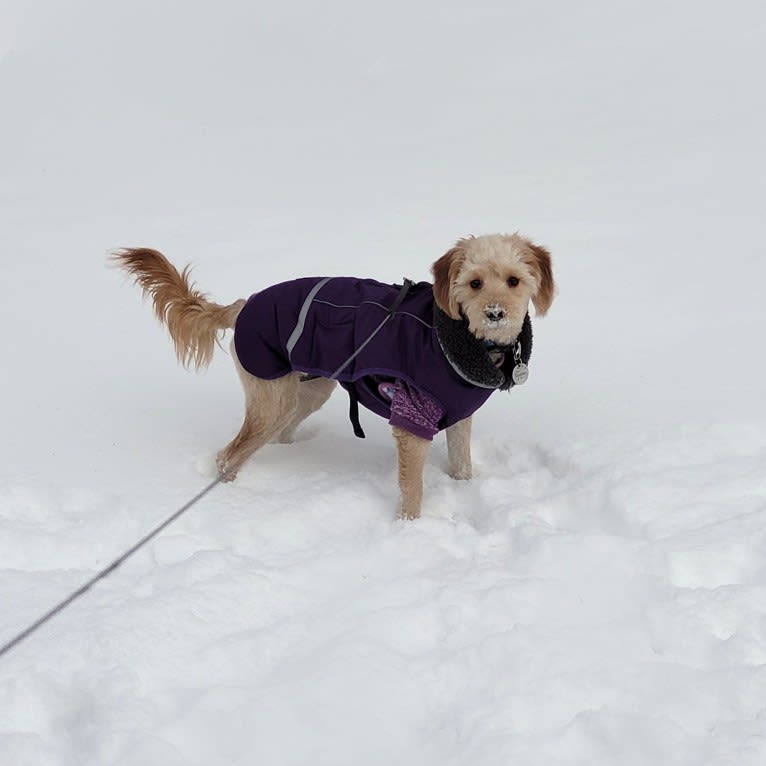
[216,356,300,481]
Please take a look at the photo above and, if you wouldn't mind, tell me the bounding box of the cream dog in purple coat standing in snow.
[112,233,556,519]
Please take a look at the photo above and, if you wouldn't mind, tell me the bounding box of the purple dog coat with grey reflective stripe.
[234,277,531,439]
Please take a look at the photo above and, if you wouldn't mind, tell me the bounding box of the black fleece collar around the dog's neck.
[434,304,532,391]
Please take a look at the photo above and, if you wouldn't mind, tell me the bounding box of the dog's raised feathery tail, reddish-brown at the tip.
[112,247,245,370]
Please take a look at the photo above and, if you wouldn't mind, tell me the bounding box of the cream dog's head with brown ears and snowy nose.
[432,234,556,346]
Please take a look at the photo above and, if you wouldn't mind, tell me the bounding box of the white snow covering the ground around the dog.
[0,0,766,766]
